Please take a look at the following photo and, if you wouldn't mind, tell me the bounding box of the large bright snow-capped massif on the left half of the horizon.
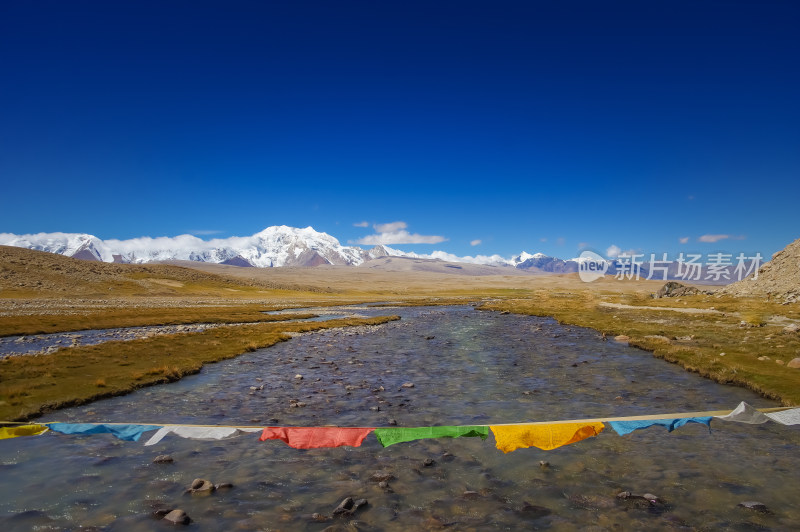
[0,225,402,268]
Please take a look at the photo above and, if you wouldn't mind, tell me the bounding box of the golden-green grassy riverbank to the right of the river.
[480,289,800,406]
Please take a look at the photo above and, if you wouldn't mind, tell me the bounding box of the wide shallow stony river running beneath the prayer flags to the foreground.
[0,307,800,531]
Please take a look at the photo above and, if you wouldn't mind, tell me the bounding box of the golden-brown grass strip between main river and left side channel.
[0,314,399,421]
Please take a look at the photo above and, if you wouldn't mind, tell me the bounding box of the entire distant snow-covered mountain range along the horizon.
[0,225,752,282]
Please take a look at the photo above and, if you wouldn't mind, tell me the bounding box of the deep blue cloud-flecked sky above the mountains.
[0,1,800,258]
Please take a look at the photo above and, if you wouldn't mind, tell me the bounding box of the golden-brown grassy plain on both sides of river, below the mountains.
[0,248,800,419]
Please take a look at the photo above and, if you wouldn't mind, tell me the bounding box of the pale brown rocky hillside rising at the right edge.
[717,238,800,303]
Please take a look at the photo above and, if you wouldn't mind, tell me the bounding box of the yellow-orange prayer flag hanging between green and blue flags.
[491,421,605,453]
